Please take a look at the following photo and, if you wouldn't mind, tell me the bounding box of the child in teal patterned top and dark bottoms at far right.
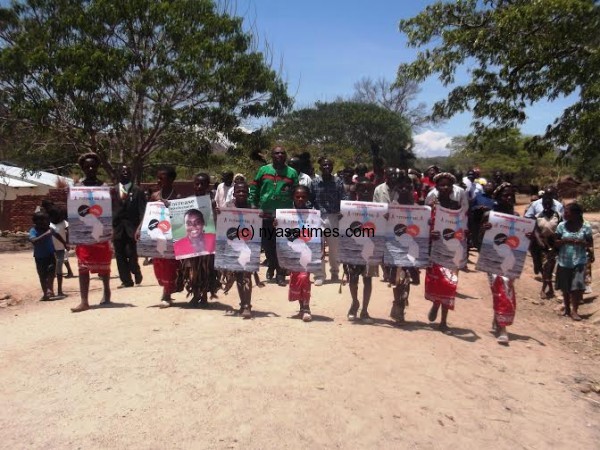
[555,203,594,320]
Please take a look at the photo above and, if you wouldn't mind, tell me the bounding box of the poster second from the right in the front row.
[431,205,468,270]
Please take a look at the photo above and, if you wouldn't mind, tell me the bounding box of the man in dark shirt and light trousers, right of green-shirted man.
[310,158,347,286]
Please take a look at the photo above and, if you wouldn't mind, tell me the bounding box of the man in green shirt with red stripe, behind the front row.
[249,147,298,286]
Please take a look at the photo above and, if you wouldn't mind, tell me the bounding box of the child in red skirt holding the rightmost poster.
[480,183,532,345]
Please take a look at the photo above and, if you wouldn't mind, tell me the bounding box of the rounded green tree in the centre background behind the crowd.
[271,101,414,167]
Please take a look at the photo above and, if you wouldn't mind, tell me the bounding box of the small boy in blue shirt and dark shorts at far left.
[29,210,55,301]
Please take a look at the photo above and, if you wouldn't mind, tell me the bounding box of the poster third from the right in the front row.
[383,204,431,267]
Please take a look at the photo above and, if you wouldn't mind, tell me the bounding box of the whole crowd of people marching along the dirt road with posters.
[30,146,594,344]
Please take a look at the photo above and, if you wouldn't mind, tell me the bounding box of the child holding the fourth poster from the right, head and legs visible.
[344,178,379,324]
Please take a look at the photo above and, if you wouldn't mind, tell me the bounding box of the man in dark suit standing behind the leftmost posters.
[113,165,146,287]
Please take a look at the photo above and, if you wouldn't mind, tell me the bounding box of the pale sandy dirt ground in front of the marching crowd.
[0,217,600,449]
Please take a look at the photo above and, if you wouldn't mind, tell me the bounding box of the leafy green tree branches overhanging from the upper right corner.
[398,0,600,165]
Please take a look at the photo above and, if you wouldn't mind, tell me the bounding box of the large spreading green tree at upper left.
[0,0,291,177]
